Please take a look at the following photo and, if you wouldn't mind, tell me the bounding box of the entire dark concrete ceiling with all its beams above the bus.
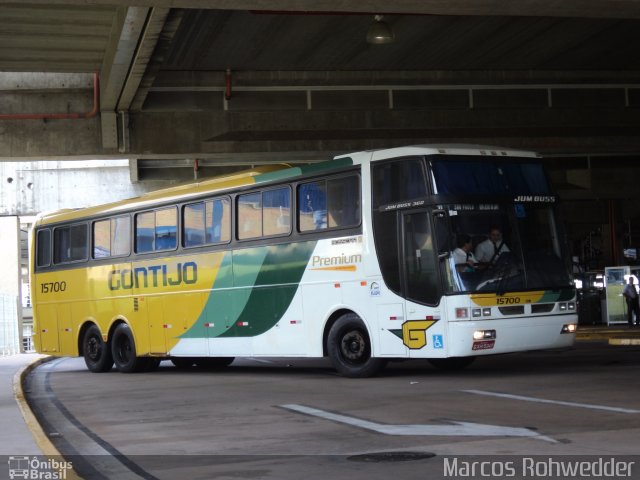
[0,0,640,163]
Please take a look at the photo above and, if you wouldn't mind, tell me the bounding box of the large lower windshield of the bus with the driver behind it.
[438,203,571,295]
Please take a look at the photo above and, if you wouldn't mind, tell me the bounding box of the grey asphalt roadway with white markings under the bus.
[25,342,640,480]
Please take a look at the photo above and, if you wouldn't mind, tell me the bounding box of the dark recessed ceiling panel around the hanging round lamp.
[163,10,640,72]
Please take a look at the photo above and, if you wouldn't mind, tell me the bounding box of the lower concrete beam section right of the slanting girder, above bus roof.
[127,108,640,156]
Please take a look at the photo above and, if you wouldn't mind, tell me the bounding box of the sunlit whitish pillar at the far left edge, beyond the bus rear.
[0,216,22,354]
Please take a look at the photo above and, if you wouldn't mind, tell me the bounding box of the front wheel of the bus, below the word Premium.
[327,313,387,378]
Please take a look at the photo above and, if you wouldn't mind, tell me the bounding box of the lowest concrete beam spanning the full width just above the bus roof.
[0,102,640,161]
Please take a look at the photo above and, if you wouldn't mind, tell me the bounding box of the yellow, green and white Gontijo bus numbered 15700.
[31,146,577,377]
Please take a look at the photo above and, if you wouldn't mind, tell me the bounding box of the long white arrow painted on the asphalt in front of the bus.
[281,404,557,443]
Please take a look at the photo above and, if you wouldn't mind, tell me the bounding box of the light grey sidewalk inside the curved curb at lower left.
[0,353,44,455]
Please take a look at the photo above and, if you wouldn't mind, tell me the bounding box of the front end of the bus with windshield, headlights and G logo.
[372,147,577,368]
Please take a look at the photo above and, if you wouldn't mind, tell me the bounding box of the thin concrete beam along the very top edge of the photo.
[0,0,640,18]
